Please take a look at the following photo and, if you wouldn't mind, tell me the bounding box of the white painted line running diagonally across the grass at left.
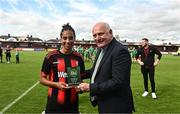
[0,81,39,114]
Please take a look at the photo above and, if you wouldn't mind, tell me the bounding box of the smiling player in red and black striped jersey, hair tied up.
[40,24,89,113]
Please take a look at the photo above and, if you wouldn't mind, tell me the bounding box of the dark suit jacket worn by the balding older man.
[90,38,134,113]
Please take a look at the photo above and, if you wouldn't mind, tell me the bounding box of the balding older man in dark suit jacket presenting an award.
[79,22,134,113]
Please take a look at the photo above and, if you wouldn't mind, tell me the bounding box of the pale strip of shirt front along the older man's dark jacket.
[91,49,104,83]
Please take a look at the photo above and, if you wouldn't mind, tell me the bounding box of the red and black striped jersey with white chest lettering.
[41,50,85,110]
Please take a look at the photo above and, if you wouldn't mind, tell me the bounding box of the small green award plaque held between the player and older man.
[67,66,81,87]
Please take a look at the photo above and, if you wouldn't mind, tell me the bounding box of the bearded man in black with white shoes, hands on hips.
[136,38,162,99]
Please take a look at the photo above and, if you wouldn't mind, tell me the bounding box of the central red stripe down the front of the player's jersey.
[57,58,66,104]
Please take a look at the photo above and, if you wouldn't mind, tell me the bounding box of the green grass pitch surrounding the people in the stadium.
[0,51,180,113]
